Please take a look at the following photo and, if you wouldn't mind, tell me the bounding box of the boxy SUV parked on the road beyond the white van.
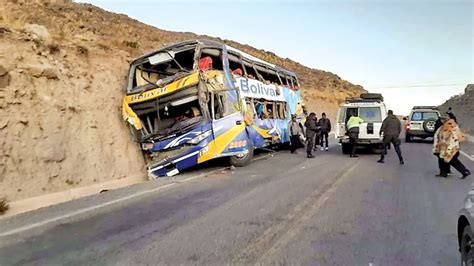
[404,106,440,142]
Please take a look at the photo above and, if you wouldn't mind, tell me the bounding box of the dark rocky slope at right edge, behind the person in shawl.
[440,84,474,135]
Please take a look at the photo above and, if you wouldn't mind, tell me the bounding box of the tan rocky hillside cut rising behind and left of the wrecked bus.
[0,0,363,200]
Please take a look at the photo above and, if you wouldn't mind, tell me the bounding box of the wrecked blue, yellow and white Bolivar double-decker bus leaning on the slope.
[122,40,303,178]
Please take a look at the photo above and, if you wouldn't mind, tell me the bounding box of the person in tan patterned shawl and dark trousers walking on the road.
[433,119,471,179]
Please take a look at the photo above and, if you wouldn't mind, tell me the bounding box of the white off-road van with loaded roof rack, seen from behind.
[336,93,387,154]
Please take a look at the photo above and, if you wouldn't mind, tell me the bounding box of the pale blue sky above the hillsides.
[78,0,474,114]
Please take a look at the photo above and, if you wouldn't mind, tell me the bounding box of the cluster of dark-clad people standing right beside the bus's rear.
[288,110,331,158]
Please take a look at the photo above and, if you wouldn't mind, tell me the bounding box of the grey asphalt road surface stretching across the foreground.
[0,138,474,266]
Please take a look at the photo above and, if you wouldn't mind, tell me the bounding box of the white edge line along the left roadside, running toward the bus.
[0,152,270,237]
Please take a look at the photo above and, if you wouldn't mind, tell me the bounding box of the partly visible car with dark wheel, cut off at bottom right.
[457,188,474,265]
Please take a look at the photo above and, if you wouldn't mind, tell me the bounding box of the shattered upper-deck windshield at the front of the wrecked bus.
[128,45,196,93]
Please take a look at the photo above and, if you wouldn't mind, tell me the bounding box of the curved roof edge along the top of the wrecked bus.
[132,39,296,77]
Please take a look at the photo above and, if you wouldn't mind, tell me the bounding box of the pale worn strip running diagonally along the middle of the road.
[233,160,360,265]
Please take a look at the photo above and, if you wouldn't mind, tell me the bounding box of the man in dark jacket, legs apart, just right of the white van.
[377,110,404,164]
